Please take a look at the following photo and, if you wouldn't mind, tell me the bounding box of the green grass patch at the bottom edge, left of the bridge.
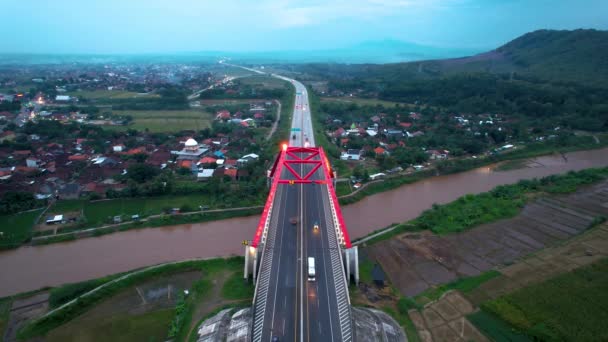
[45,309,173,342]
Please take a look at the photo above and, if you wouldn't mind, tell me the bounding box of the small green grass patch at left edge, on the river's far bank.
[0,209,43,249]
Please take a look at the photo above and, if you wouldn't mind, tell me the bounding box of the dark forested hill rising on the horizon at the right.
[366,29,608,85]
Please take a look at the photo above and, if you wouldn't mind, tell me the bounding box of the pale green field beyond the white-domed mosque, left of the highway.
[108,109,214,132]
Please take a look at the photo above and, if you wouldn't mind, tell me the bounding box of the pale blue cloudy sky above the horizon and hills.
[0,0,608,53]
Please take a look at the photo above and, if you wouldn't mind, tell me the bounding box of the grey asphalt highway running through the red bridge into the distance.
[254,75,344,341]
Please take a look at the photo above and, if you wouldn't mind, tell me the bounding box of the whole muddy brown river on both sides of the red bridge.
[0,149,608,297]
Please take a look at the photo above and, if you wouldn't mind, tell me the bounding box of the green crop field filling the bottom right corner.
[482,258,608,341]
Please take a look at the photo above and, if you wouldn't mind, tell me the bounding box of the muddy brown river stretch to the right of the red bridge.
[342,149,608,239]
